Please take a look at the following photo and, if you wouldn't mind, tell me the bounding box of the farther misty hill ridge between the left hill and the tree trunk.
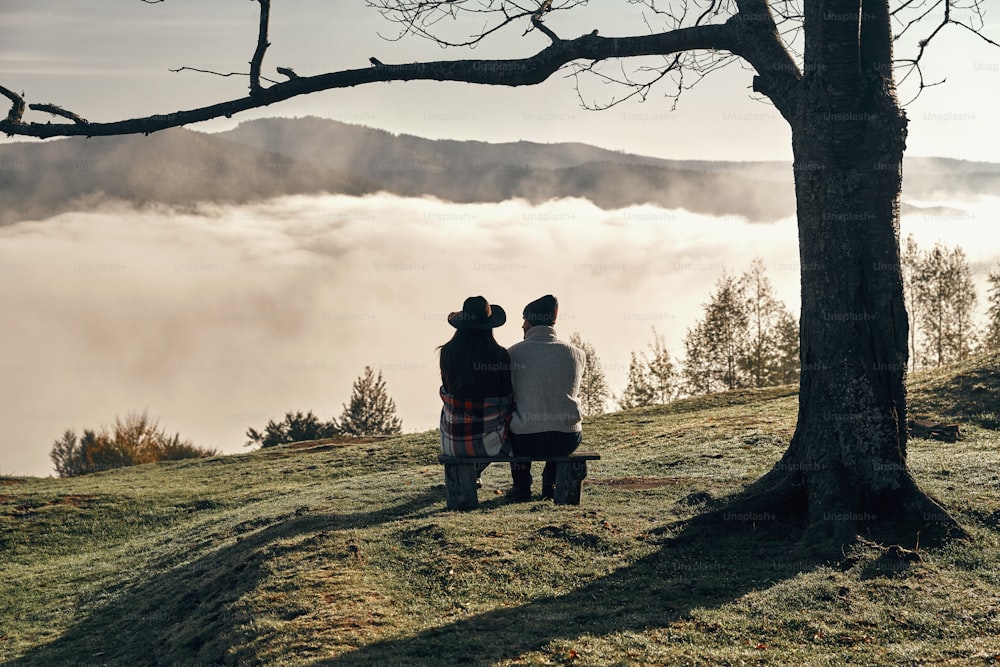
[218,118,795,221]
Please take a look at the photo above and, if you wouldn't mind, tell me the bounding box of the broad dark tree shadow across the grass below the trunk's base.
[311,526,823,667]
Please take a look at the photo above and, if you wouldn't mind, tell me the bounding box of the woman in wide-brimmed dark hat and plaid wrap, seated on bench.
[440,296,514,464]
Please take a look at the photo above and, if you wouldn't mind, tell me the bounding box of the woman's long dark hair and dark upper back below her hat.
[439,329,512,398]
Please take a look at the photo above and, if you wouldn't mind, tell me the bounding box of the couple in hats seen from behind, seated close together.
[440,294,584,500]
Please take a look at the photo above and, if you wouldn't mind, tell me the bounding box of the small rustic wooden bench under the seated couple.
[438,452,601,510]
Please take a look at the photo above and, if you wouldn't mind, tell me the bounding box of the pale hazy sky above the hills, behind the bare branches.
[0,0,1000,161]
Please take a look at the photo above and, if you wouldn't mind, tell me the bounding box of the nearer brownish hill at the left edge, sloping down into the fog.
[0,129,377,224]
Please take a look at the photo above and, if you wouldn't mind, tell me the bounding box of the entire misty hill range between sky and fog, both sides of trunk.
[0,117,1000,224]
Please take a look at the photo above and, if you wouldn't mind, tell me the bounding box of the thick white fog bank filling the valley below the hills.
[0,190,1000,475]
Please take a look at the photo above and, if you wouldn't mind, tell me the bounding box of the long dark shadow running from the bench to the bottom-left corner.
[4,489,442,667]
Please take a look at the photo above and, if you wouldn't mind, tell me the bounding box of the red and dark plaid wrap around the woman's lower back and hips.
[441,387,514,457]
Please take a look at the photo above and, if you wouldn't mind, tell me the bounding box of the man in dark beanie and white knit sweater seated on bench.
[507,294,585,500]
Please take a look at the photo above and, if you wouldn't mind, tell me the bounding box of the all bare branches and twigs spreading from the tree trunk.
[0,0,984,137]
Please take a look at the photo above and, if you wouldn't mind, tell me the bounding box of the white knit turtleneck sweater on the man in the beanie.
[509,325,585,434]
